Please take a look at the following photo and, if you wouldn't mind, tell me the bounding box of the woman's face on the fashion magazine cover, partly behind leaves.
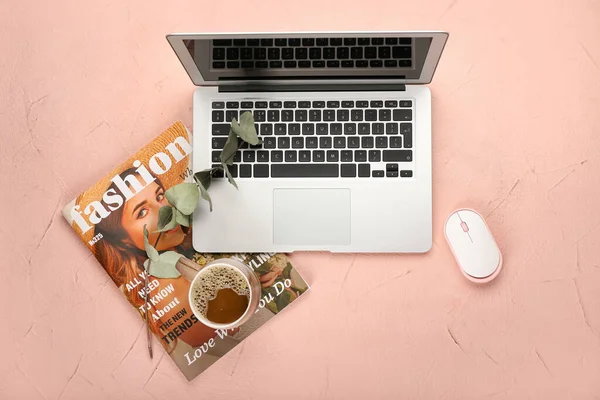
[121,182,185,251]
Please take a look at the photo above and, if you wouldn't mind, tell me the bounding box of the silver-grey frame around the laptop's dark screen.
[166,31,448,86]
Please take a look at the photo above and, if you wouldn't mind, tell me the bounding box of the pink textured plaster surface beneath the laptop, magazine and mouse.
[0,0,600,399]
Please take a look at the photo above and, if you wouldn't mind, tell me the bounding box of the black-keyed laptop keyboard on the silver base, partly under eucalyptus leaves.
[211,100,414,178]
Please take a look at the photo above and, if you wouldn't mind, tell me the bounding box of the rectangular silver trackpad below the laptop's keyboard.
[273,189,350,245]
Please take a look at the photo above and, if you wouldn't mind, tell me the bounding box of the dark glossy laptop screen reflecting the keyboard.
[183,35,432,81]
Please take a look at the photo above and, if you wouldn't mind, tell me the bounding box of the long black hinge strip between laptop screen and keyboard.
[219,83,406,93]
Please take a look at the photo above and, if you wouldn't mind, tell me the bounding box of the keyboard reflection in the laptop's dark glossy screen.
[212,37,412,69]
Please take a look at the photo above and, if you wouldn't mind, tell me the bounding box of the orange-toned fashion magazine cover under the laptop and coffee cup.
[63,122,309,380]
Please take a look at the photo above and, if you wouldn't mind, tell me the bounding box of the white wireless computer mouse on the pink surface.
[444,208,502,283]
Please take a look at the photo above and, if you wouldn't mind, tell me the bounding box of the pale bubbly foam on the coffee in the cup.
[193,265,250,317]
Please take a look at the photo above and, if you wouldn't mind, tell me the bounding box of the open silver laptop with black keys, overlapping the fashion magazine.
[167,32,448,253]
